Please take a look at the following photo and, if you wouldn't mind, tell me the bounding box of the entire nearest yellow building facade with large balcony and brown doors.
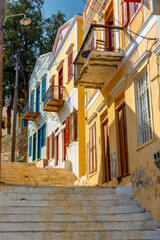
[74,0,160,221]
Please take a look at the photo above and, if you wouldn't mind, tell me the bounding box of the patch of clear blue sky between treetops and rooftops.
[44,0,85,20]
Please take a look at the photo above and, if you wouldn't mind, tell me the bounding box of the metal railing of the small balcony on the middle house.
[44,86,67,106]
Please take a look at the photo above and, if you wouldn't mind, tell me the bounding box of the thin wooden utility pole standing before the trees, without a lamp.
[11,51,19,162]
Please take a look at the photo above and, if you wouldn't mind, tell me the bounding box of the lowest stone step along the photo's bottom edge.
[0,230,160,240]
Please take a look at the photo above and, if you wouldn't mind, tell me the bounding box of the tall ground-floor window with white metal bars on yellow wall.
[135,68,152,145]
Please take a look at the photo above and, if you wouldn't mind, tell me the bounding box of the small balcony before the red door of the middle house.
[43,86,67,112]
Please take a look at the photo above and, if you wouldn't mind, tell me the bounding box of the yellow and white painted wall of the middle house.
[47,15,86,177]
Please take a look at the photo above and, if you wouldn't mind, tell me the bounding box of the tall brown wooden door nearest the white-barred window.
[118,104,129,176]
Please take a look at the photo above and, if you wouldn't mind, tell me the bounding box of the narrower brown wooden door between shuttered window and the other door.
[103,121,111,182]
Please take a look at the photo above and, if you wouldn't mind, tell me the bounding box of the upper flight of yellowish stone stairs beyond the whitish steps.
[0,161,77,186]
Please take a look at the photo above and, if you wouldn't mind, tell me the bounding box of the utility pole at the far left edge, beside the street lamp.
[0,0,5,182]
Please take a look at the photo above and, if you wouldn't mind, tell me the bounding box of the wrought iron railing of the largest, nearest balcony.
[74,24,125,87]
